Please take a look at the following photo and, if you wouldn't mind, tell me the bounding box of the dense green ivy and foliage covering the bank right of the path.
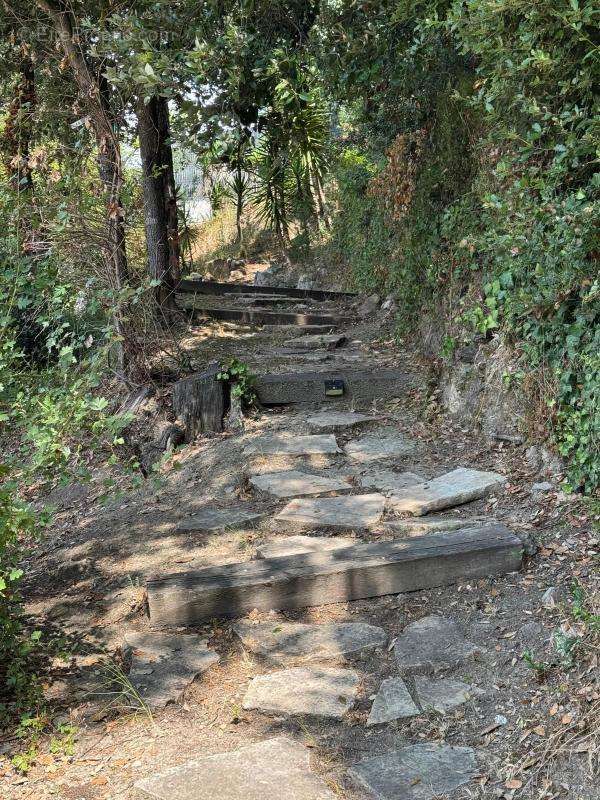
[325,0,600,492]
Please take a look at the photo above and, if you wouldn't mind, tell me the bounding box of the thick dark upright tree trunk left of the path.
[137,96,179,322]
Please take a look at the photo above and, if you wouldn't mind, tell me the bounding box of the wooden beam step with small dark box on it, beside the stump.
[255,369,411,406]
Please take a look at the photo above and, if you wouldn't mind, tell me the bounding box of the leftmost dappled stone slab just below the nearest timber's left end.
[124,632,219,711]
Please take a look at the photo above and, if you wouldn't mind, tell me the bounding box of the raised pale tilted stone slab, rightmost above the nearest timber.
[391,467,506,516]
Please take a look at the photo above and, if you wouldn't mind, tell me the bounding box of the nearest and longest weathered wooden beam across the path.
[147,524,523,626]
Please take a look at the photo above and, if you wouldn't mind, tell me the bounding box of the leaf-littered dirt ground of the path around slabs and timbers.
[0,276,600,800]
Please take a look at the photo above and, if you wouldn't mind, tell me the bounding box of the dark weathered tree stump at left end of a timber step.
[173,364,229,442]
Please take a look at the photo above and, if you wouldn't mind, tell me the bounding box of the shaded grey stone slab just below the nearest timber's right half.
[394,615,485,673]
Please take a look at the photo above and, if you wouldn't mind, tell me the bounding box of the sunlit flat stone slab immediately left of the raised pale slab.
[275,494,385,530]
